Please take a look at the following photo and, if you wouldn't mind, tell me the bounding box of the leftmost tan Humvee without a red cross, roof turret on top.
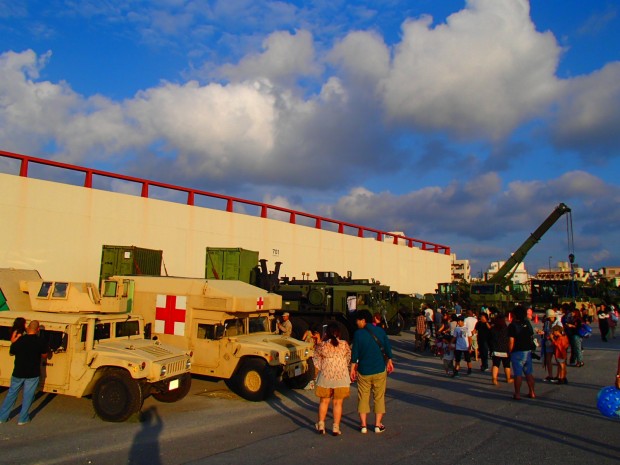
[0,279,191,422]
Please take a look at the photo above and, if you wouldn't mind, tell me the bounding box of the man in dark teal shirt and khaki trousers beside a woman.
[351,310,394,433]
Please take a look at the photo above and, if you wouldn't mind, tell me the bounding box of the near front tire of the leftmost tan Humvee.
[92,369,143,422]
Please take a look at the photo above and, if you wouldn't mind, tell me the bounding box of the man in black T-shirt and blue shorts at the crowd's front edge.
[508,306,536,400]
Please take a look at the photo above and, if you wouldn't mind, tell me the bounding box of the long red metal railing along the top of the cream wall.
[0,150,450,255]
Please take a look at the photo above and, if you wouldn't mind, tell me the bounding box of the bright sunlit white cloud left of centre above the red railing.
[125,82,276,177]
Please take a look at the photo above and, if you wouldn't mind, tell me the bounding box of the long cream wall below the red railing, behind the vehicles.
[0,174,451,294]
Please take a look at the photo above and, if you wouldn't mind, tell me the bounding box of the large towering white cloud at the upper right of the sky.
[383,0,560,138]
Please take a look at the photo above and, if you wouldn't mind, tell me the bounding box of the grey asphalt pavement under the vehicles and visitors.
[0,322,620,465]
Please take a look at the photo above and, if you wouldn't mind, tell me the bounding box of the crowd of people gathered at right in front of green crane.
[422,304,618,399]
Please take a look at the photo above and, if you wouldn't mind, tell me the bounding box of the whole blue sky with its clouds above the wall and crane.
[0,0,620,274]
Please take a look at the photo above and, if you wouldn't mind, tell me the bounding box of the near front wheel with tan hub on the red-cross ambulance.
[226,358,276,402]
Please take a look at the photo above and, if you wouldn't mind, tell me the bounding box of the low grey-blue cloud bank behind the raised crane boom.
[327,171,620,267]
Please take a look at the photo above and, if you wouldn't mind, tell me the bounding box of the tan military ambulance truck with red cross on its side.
[102,276,314,401]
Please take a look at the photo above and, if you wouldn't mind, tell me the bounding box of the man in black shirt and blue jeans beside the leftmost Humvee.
[0,320,49,425]
